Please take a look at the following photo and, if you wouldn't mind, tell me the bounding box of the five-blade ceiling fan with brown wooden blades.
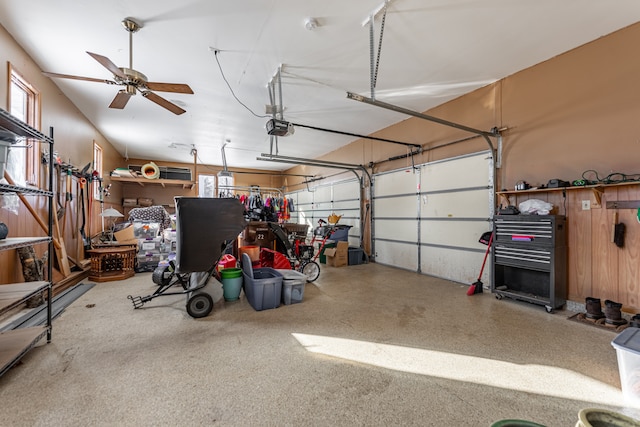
[42,18,193,114]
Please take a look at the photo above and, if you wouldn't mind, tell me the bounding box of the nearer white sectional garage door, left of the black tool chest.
[373,151,494,283]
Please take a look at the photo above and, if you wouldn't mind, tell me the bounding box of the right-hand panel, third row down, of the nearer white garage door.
[420,220,491,249]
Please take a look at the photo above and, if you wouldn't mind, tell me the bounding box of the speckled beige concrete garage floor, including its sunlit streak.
[0,264,640,426]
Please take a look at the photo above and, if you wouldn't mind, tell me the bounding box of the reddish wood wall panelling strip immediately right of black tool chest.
[566,190,593,302]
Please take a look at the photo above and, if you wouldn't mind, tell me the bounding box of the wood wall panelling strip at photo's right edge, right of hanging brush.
[611,185,640,312]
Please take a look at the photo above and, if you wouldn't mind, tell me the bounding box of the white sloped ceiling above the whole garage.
[0,0,640,170]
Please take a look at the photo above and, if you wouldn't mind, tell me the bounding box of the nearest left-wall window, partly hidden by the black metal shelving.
[7,64,40,185]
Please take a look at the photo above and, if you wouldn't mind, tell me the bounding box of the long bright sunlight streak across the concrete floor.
[292,333,623,405]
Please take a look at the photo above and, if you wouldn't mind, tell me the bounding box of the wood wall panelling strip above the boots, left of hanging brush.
[589,188,620,302]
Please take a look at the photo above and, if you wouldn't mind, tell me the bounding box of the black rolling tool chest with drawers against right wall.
[491,215,567,313]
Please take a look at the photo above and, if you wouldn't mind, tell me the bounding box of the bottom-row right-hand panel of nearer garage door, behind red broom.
[420,246,490,285]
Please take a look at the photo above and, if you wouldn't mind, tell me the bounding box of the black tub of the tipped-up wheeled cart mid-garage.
[175,197,247,273]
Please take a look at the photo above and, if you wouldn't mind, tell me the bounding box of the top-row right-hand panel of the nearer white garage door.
[420,152,491,191]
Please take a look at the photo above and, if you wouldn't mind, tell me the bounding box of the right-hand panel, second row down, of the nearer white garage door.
[420,189,489,218]
